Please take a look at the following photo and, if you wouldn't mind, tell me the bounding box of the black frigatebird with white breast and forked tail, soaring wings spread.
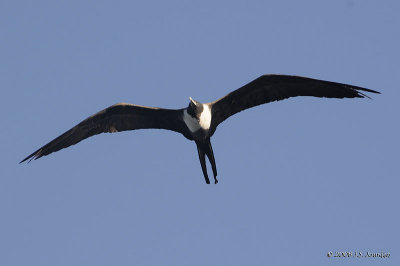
[20,75,380,184]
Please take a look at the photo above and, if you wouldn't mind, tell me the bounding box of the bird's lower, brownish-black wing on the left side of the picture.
[20,103,190,163]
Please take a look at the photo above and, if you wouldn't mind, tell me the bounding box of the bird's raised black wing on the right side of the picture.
[211,75,379,130]
